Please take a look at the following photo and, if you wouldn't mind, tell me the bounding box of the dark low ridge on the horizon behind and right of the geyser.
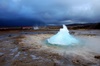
[48,22,100,30]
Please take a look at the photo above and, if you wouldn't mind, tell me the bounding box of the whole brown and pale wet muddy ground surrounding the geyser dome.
[0,30,100,66]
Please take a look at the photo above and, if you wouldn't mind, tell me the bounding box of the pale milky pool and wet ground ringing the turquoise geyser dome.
[22,34,100,54]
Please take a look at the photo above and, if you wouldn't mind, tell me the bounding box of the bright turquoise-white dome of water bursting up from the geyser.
[47,25,79,45]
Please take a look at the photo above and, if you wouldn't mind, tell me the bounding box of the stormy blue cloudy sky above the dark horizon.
[0,0,100,25]
